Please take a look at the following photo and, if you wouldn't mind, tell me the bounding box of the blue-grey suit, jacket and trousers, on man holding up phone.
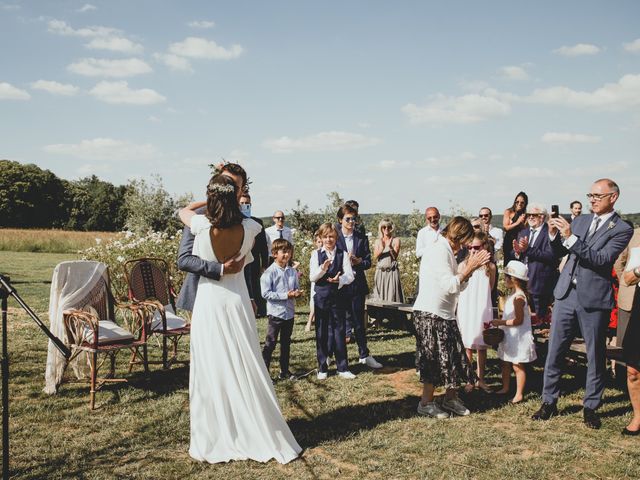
[542,213,633,410]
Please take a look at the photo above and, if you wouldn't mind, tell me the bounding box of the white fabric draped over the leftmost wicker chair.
[43,260,108,394]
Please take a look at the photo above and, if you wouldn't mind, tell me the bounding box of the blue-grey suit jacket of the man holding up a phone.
[553,213,633,310]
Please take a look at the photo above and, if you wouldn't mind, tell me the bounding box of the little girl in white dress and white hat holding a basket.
[491,260,537,403]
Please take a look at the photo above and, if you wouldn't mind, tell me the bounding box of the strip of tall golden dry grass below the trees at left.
[0,228,118,253]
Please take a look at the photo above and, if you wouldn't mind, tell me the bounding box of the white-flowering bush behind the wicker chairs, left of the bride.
[79,230,184,298]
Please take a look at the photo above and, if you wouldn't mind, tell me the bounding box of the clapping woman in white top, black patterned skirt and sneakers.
[413,217,491,418]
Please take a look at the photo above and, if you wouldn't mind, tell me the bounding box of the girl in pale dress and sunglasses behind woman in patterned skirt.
[458,231,496,392]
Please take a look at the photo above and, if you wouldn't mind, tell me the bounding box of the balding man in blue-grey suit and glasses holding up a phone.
[532,178,633,429]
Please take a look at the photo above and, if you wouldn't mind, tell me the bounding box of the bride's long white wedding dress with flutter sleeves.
[189,215,302,463]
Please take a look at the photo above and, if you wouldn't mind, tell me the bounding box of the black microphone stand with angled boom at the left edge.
[0,275,71,480]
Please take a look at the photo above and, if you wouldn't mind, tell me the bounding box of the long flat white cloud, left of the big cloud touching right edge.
[402,93,511,125]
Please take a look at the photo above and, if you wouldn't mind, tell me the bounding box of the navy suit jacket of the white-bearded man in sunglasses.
[518,223,560,295]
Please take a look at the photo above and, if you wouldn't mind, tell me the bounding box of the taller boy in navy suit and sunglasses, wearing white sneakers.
[336,204,382,368]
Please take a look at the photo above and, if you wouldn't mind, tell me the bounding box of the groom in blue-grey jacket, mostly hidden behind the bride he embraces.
[176,163,251,311]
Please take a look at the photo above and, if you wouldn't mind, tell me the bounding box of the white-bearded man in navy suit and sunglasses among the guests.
[513,203,560,322]
